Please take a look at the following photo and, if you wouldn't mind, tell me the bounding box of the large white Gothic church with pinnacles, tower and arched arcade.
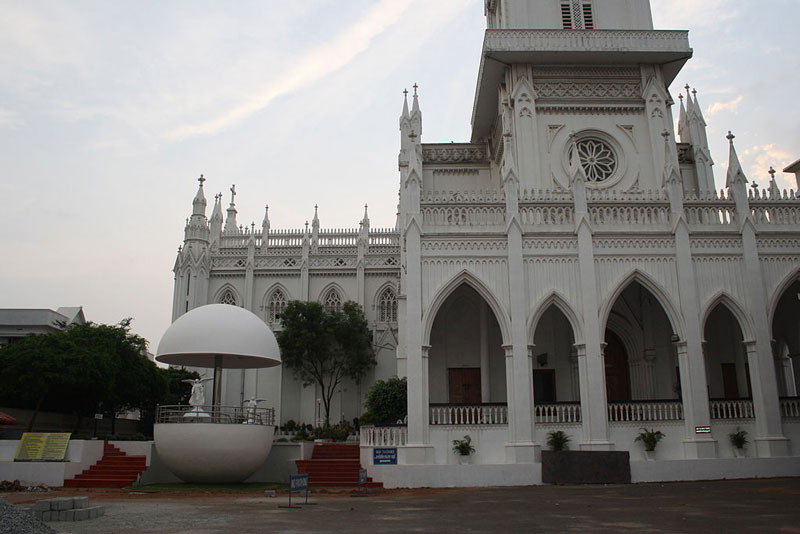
[173,0,800,486]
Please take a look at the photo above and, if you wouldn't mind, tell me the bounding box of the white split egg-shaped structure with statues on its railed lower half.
[153,304,281,483]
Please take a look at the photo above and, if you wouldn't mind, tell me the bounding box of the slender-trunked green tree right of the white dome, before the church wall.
[277,300,376,425]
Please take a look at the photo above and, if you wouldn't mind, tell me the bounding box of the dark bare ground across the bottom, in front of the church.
[0,478,800,534]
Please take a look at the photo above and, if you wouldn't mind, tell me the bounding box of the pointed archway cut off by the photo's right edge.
[772,279,800,397]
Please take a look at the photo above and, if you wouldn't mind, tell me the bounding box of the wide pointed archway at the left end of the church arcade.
[428,283,506,405]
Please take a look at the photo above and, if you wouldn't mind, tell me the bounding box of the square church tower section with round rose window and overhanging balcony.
[472,0,692,192]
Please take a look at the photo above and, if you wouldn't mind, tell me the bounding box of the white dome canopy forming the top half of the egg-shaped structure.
[156,304,281,369]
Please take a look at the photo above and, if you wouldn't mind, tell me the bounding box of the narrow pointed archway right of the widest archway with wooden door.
[703,302,751,399]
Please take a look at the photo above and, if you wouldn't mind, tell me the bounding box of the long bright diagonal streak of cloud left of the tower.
[167,0,412,141]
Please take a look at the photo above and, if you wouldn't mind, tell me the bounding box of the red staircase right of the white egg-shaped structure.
[296,443,383,488]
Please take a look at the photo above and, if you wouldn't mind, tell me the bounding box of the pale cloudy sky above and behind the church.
[0,0,800,351]
